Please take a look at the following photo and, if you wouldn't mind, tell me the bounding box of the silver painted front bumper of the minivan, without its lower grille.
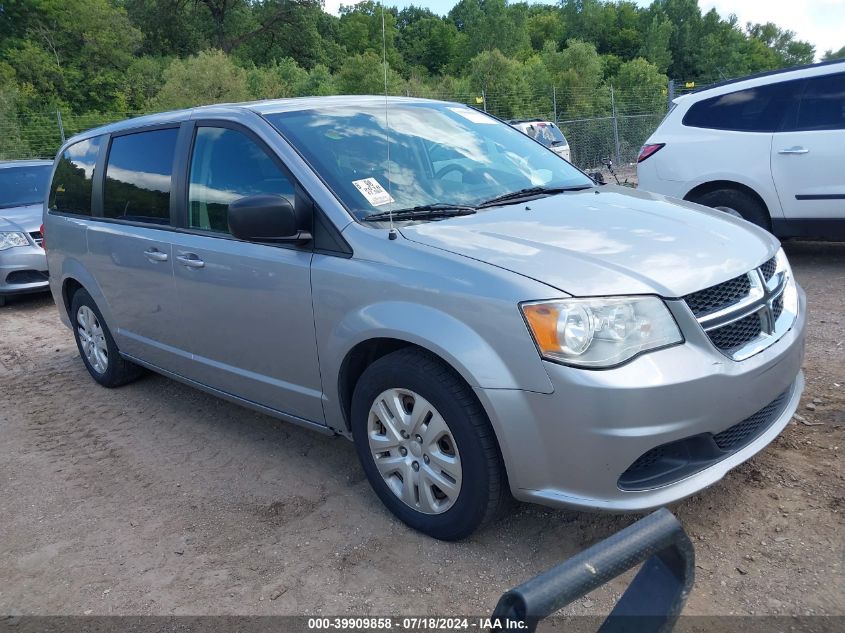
[476,290,806,512]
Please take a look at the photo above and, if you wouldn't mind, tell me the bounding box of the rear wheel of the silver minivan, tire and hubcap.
[70,289,143,387]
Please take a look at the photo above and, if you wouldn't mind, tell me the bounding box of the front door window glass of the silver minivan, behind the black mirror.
[188,126,295,233]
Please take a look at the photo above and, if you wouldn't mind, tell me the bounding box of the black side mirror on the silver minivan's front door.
[228,193,311,243]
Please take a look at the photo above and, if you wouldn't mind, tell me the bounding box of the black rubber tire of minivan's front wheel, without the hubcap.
[352,348,511,541]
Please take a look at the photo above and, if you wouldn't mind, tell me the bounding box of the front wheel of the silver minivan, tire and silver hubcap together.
[352,349,510,540]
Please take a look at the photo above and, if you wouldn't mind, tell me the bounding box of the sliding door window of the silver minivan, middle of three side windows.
[103,128,179,224]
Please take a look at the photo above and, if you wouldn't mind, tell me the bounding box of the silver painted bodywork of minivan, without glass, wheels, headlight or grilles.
[44,97,806,510]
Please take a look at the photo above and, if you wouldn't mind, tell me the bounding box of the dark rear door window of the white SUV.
[683,80,802,132]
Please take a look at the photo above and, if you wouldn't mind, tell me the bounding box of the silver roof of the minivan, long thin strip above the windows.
[62,95,463,141]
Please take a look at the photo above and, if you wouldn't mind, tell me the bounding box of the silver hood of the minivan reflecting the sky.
[401,185,778,299]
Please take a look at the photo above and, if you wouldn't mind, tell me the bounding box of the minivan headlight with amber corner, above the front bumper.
[520,297,684,368]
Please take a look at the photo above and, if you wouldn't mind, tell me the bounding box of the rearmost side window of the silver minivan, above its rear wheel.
[47,136,102,215]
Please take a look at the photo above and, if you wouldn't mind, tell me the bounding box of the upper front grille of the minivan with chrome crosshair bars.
[683,256,797,361]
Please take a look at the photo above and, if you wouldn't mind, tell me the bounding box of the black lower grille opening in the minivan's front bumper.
[617,386,792,490]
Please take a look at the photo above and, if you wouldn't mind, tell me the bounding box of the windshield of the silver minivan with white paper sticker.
[266,103,593,219]
